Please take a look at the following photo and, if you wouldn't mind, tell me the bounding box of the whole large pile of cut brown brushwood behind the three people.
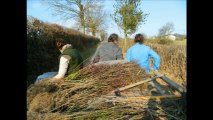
[27,63,186,120]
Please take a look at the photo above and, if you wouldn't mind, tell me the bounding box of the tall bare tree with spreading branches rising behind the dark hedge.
[46,0,96,34]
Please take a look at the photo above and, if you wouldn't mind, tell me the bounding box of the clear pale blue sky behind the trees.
[27,0,187,37]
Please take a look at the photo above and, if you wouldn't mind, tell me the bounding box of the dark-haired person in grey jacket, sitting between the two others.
[92,34,123,63]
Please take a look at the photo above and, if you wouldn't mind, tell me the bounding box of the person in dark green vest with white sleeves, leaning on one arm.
[36,39,83,82]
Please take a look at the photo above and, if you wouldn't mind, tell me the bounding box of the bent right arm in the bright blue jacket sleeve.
[149,48,160,71]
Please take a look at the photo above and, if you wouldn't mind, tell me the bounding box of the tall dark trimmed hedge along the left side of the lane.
[27,16,100,85]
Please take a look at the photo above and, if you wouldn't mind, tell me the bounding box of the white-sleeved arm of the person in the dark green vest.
[53,55,71,79]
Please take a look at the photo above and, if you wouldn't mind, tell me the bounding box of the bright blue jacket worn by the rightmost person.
[126,43,160,73]
